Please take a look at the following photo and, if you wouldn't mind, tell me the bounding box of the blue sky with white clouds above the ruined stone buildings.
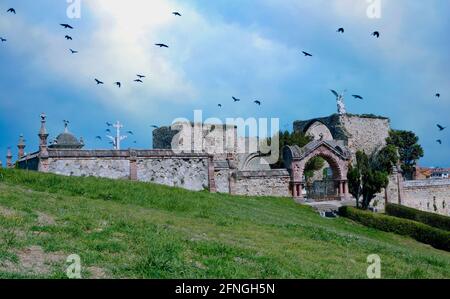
[0,0,450,167]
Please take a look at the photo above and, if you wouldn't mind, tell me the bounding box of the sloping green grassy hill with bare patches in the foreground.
[0,170,450,278]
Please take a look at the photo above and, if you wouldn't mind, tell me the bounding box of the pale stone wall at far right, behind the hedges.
[402,180,450,216]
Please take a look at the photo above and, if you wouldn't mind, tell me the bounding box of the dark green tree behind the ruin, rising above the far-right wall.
[386,130,424,179]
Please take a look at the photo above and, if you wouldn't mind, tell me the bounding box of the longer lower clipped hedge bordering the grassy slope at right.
[339,207,450,251]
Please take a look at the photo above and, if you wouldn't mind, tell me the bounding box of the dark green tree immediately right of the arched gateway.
[347,150,392,210]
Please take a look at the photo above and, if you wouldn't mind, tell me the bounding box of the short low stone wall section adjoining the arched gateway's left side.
[231,169,292,197]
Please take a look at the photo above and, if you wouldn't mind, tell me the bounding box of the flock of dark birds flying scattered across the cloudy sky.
[0,8,446,148]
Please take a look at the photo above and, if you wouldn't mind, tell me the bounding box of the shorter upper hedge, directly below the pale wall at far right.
[386,203,450,231]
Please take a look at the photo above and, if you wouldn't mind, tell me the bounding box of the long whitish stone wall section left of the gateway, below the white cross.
[34,150,215,191]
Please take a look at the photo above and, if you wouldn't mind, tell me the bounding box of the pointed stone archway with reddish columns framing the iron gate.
[283,140,351,200]
